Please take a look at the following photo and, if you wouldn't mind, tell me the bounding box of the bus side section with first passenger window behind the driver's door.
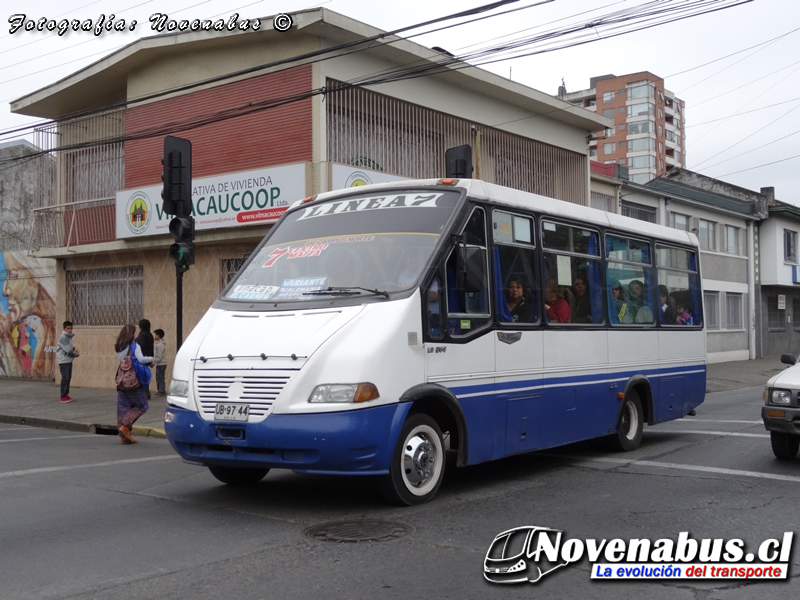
[492,209,543,458]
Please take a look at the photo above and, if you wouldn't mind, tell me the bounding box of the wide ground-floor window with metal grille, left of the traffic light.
[67,265,144,327]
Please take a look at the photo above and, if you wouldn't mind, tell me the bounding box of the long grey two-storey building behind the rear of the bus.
[592,163,767,363]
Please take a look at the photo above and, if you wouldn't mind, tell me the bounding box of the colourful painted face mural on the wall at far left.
[0,252,57,378]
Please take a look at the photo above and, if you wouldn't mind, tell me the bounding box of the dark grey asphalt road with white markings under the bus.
[0,387,800,600]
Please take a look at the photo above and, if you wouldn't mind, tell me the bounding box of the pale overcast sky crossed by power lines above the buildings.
[0,0,800,205]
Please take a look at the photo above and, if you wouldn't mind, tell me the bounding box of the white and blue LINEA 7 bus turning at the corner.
[165,179,706,505]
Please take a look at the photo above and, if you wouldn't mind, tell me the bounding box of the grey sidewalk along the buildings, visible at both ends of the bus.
[0,357,786,437]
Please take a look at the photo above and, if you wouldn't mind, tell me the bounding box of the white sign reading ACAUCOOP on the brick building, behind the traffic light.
[116,163,306,239]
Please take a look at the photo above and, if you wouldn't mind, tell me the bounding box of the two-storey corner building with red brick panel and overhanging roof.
[12,8,610,388]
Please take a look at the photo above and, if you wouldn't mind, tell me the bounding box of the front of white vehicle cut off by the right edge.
[761,354,800,459]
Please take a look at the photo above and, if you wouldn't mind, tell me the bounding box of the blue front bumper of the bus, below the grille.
[164,403,410,475]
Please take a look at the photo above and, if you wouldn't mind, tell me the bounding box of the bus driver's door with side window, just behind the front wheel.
[424,207,494,464]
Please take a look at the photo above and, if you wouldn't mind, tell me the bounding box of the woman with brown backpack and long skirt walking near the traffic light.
[114,325,153,444]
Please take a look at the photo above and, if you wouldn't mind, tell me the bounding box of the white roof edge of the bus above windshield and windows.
[304,179,698,246]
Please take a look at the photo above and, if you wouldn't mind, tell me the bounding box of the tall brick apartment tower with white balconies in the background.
[559,71,686,183]
